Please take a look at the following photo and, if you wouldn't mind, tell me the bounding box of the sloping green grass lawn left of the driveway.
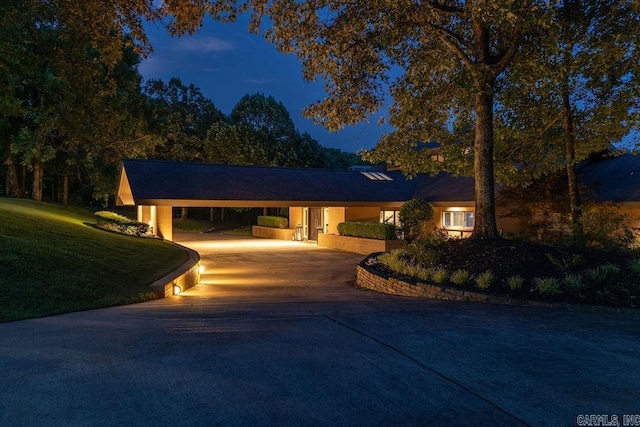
[0,198,187,322]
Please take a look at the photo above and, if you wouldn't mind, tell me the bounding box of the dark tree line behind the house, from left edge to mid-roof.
[0,0,368,203]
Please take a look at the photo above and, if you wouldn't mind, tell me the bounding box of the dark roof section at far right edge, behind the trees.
[578,154,640,203]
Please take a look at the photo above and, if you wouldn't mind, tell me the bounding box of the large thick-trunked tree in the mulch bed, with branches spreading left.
[206,0,547,238]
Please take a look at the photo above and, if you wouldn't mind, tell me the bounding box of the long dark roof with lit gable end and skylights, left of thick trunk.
[118,160,473,207]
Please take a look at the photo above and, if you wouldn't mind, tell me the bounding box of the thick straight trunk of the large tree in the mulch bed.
[471,77,500,239]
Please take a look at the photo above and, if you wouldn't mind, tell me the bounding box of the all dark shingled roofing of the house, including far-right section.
[123,154,640,206]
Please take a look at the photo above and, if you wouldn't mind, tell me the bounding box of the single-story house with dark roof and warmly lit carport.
[116,155,640,244]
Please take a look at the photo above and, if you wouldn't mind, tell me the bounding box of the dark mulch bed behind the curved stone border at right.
[373,239,640,308]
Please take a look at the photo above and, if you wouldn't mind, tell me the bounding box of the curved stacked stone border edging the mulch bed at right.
[356,252,640,314]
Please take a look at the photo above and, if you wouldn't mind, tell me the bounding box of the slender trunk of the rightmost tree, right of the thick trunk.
[562,90,584,244]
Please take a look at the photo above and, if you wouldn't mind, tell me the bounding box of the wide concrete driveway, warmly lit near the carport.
[0,236,640,426]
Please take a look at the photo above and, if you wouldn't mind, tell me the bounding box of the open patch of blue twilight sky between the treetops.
[140,19,389,152]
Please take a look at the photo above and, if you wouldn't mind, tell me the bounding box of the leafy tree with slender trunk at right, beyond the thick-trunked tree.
[497,0,640,242]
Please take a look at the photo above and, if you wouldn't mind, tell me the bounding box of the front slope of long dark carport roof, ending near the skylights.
[123,160,415,206]
